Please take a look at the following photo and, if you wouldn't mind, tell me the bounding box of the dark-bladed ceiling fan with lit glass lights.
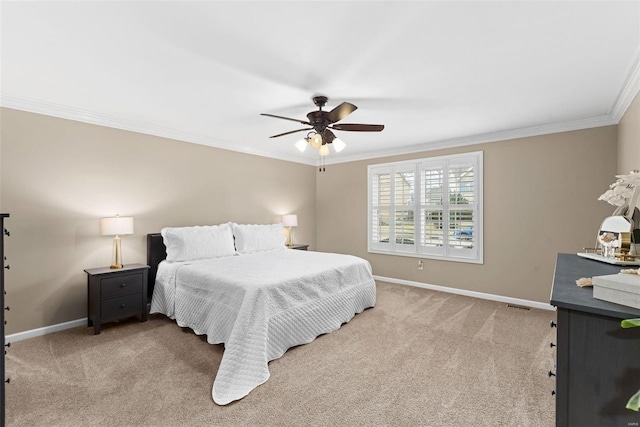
[260,95,384,156]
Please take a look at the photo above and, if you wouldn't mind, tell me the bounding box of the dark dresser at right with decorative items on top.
[550,254,640,427]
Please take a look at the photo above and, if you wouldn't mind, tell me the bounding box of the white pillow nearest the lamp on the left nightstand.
[160,224,236,261]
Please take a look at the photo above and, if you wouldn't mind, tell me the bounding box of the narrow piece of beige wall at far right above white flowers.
[618,93,640,174]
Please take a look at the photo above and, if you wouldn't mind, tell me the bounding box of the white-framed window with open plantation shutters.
[368,152,482,263]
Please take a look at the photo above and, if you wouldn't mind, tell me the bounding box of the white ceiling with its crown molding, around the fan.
[0,0,640,164]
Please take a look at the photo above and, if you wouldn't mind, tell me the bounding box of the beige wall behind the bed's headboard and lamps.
[0,109,316,334]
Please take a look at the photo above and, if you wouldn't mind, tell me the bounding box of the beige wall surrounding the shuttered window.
[316,126,617,303]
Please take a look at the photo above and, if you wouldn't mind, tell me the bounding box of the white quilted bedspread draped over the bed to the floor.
[151,249,376,405]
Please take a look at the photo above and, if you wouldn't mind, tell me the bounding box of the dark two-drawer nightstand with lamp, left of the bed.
[85,264,149,335]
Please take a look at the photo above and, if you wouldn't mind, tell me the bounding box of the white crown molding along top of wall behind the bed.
[0,94,315,166]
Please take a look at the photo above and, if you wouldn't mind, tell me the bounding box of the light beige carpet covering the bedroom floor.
[6,283,555,427]
